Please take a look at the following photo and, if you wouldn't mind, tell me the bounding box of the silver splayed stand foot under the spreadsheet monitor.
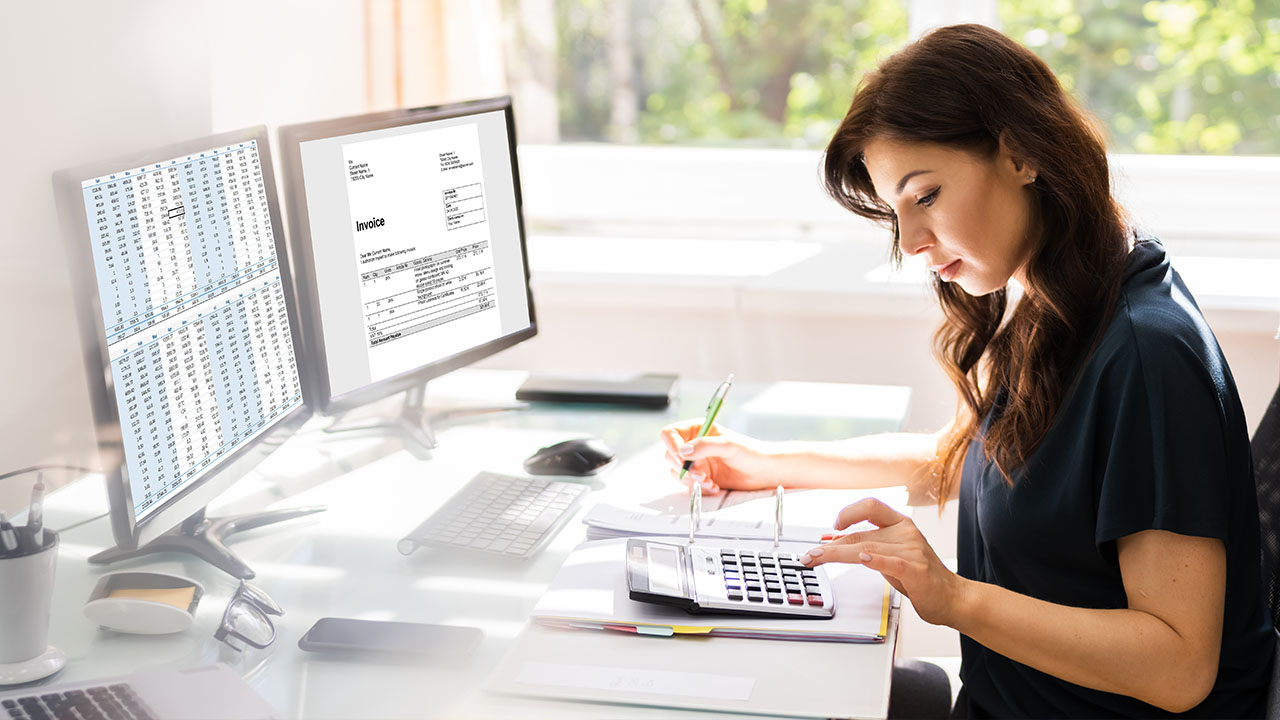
[88,506,324,580]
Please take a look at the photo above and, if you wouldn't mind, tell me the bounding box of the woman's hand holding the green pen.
[662,419,777,493]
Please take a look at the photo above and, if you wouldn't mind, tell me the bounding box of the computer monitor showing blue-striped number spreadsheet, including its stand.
[54,127,315,578]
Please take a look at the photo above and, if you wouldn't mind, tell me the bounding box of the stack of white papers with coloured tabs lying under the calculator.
[532,538,892,642]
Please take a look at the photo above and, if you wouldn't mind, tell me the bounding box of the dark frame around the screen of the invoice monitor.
[278,96,538,415]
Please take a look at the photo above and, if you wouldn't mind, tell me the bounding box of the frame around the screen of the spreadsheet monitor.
[54,126,311,550]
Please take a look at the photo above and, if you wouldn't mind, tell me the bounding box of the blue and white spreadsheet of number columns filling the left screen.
[82,141,302,519]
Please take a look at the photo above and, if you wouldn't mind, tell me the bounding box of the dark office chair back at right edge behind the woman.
[1252,379,1280,720]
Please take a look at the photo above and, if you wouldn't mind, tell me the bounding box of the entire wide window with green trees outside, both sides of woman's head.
[504,0,1280,155]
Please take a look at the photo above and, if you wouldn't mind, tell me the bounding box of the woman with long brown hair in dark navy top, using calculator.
[663,26,1275,717]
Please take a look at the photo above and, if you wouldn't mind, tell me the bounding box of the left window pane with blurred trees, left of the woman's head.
[545,0,906,147]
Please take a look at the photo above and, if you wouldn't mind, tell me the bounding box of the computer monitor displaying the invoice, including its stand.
[280,97,538,451]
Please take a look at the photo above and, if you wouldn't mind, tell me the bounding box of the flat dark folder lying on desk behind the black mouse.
[516,373,677,409]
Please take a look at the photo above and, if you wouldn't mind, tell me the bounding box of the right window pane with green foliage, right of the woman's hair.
[1000,0,1280,155]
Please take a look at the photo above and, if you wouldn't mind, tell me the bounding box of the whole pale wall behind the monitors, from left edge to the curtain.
[0,0,365,511]
